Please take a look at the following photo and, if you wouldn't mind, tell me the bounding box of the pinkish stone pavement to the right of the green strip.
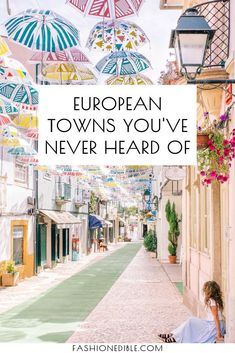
[68,248,191,343]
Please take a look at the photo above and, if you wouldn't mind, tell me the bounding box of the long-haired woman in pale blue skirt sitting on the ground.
[158,281,225,343]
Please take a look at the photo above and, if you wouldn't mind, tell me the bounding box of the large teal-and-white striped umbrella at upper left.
[5,9,79,52]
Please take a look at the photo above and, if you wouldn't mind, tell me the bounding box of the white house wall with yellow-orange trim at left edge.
[0,147,35,278]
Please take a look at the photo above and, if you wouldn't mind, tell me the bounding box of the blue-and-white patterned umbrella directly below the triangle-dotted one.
[96,51,151,75]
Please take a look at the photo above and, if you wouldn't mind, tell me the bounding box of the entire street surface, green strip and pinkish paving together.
[0,243,190,343]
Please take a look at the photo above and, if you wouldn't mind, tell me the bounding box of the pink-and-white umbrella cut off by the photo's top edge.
[68,0,143,19]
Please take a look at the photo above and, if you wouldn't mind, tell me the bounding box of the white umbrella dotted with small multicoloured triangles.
[86,21,148,51]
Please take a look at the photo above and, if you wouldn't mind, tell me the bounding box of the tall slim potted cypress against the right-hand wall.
[165,200,180,264]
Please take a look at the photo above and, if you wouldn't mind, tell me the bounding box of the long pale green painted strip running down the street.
[0,243,141,343]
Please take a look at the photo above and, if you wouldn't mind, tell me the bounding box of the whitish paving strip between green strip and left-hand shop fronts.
[0,243,125,314]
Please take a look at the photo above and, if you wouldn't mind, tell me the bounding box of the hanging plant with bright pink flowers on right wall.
[197,106,235,185]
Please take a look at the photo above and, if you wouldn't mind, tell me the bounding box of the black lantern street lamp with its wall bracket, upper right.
[170,8,235,84]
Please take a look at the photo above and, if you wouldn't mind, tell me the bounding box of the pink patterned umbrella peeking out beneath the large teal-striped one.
[29,48,90,64]
